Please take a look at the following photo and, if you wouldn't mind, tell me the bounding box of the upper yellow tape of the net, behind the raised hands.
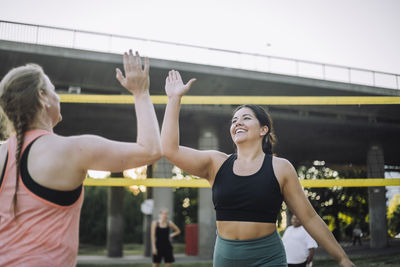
[60,94,400,105]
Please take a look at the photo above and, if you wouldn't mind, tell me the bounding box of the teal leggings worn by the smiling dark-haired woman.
[213,231,287,267]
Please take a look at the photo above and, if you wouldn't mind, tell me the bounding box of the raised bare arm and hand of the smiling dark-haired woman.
[161,70,227,183]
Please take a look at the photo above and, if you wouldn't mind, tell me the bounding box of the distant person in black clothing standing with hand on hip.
[151,208,181,267]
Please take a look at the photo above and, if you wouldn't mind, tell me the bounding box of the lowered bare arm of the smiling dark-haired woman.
[273,157,355,267]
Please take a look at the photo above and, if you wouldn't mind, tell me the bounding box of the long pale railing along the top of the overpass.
[0,20,400,90]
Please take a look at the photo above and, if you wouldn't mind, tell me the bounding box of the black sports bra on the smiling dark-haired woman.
[212,154,283,223]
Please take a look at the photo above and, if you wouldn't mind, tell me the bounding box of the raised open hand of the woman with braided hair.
[116,49,150,95]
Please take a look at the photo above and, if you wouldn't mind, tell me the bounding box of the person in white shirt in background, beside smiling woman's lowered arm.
[282,214,318,267]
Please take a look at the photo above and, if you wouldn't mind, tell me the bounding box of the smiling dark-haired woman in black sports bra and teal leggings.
[161,70,354,267]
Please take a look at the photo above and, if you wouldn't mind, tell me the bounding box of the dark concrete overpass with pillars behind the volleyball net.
[0,24,400,258]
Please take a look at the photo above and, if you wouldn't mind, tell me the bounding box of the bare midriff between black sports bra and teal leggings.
[217,221,276,240]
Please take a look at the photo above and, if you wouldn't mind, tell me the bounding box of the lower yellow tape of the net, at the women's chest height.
[83,178,400,187]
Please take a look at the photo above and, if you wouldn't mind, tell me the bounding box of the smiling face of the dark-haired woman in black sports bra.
[230,107,268,145]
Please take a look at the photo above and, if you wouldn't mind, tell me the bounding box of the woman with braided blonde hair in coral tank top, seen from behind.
[0,50,161,267]
